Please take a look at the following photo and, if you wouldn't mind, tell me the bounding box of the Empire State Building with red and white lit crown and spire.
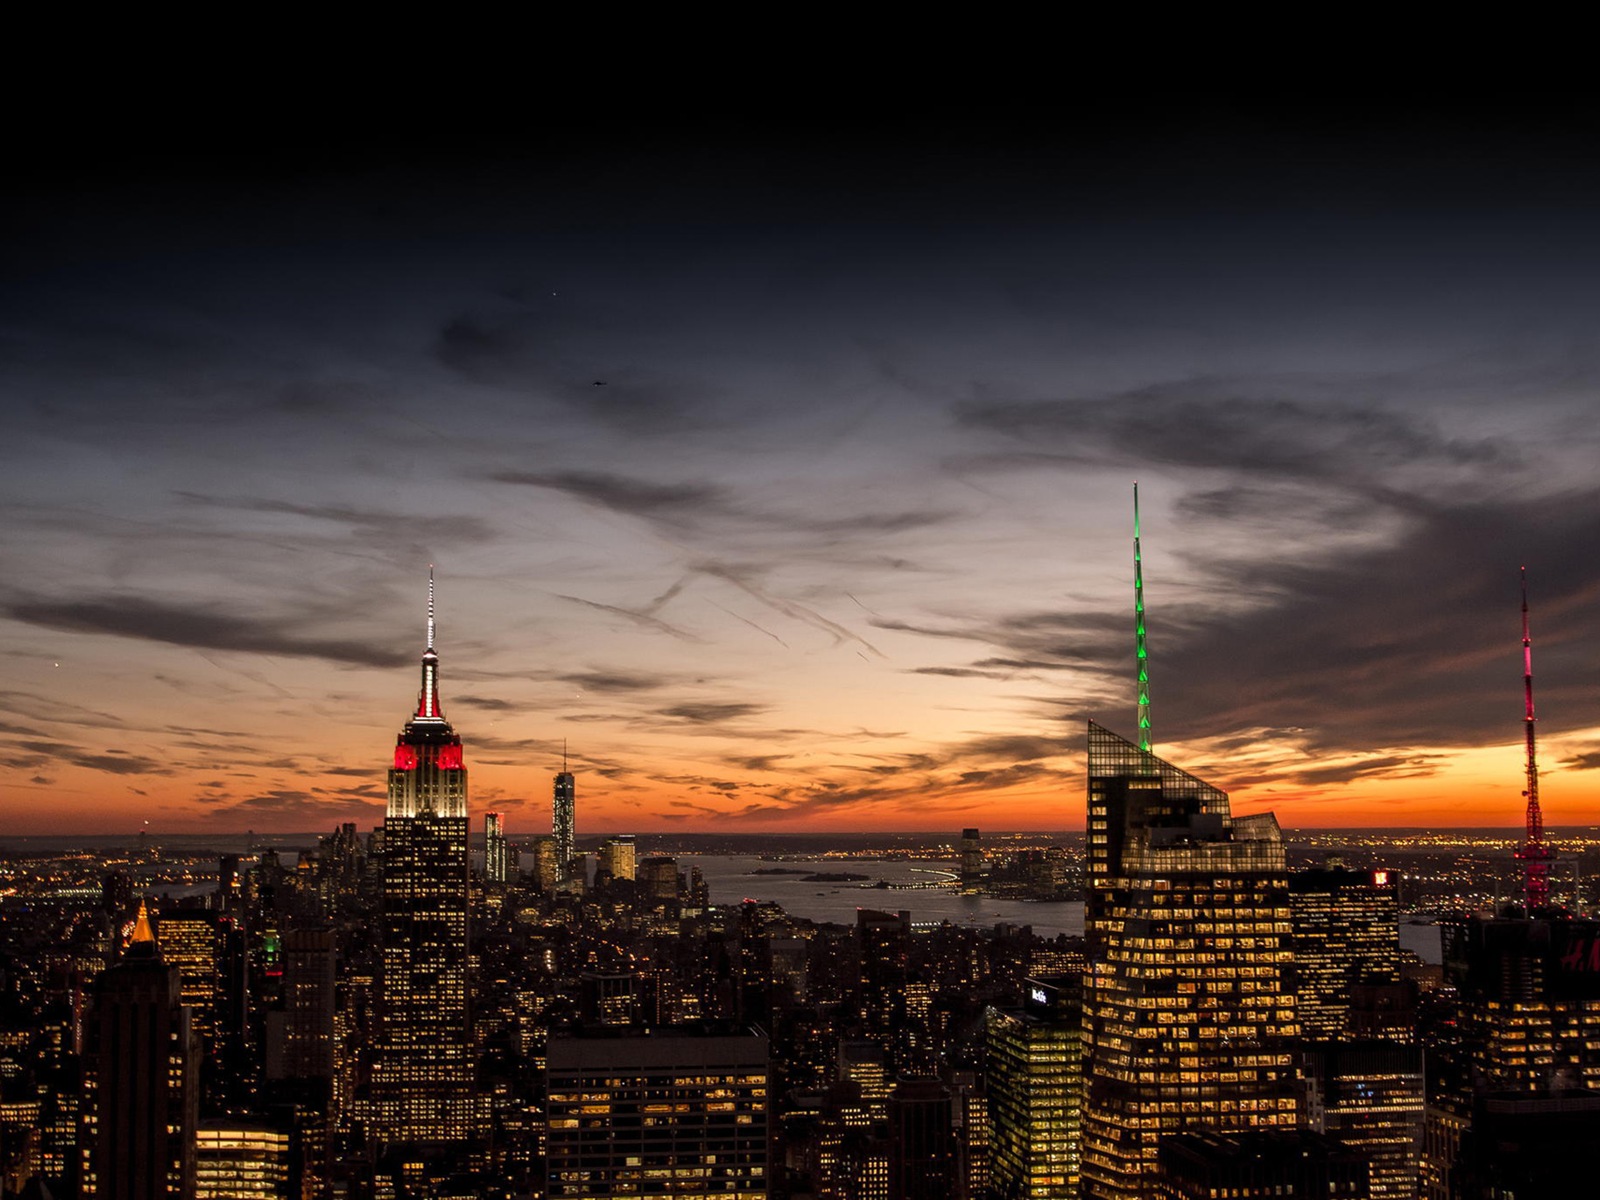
[370,571,472,1144]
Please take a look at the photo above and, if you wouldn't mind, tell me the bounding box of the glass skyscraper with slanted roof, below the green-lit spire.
[1083,723,1299,1200]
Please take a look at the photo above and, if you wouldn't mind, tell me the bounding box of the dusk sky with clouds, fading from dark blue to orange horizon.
[0,91,1600,835]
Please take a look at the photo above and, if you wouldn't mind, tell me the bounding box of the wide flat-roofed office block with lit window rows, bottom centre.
[544,1029,770,1200]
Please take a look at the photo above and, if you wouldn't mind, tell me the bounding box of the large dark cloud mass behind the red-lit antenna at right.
[1104,493,1600,761]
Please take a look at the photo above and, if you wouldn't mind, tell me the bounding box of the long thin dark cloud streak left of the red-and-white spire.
[0,595,410,667]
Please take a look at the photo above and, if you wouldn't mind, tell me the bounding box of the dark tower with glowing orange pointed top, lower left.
[78,904,200,1200]
